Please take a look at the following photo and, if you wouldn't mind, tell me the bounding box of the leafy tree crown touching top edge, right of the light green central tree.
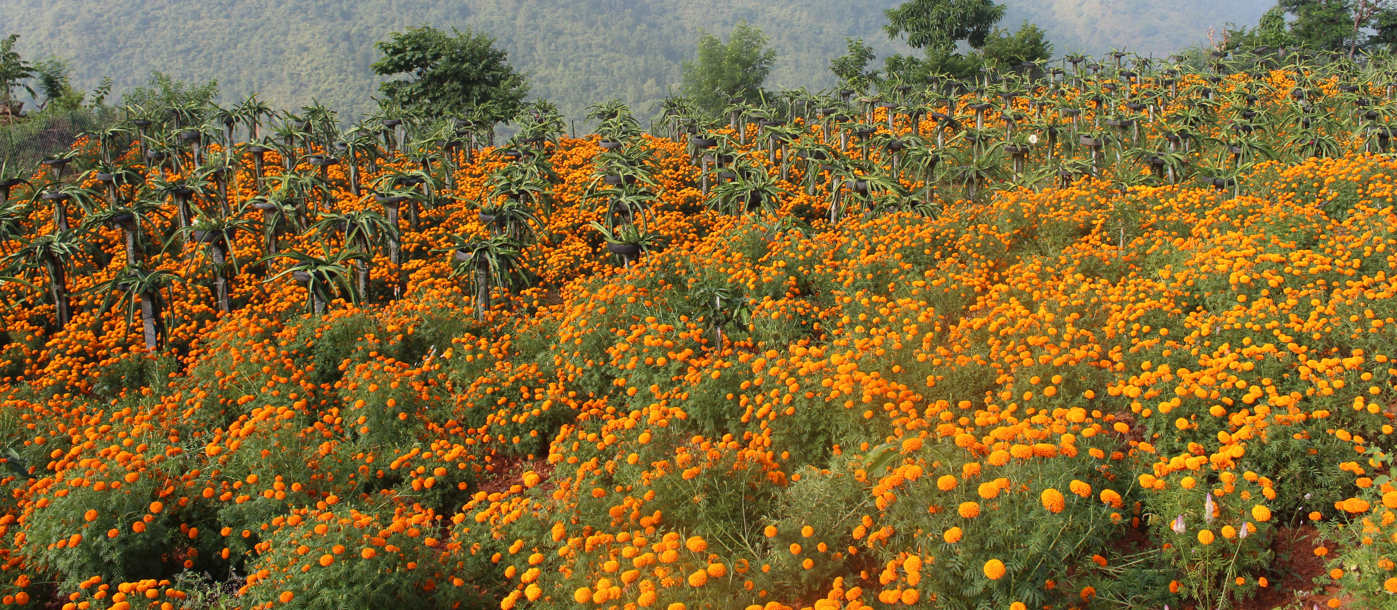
[883,0,1004,50]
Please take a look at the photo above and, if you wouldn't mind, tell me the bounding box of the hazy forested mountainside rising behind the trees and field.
[0,0,1271,119]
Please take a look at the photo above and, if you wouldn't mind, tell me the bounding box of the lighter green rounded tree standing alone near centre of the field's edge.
[683,21,777,112]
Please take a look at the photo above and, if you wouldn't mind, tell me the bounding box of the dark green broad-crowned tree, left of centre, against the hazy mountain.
[373,27,529,121]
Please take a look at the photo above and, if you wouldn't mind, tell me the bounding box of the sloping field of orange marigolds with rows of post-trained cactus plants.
[0,61,1397,610]
